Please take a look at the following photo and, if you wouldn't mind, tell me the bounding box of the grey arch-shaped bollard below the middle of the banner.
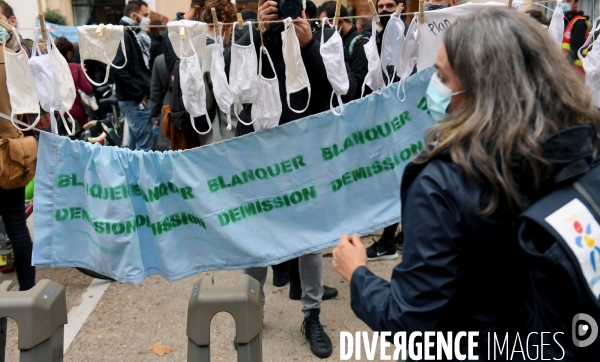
[187,274,263,362]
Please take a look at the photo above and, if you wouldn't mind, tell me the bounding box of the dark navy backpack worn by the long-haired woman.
[517,144,600,361]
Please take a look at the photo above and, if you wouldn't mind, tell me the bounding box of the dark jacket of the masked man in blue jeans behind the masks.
[110,22,151,102]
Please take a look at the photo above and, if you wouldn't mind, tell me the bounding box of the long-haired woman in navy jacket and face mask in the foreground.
[333,7,600,361]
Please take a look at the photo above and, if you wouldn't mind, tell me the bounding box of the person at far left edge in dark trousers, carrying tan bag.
[0,1,35,291]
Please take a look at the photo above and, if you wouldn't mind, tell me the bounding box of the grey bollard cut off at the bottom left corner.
[0,279,67,362]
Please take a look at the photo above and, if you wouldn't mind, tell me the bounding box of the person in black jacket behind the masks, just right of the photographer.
[318,1,369,100]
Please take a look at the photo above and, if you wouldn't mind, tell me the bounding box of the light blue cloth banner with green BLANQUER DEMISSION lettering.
[33,69,433,284]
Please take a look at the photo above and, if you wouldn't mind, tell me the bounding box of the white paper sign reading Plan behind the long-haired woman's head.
[417,1,506,71]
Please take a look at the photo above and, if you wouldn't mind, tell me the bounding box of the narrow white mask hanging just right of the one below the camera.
[319,17,350,116]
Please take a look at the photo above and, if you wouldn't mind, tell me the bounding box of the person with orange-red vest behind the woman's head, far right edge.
[561,0,588,74]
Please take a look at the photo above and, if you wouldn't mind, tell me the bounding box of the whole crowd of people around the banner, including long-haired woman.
[0,0,600,358]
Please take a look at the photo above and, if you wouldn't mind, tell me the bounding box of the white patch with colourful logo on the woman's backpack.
[546,199,600,298]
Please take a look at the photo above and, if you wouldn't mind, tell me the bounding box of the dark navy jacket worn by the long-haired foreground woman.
[351,127,593,360]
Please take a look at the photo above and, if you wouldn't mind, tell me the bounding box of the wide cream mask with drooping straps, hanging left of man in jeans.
[77,24,127,86]
